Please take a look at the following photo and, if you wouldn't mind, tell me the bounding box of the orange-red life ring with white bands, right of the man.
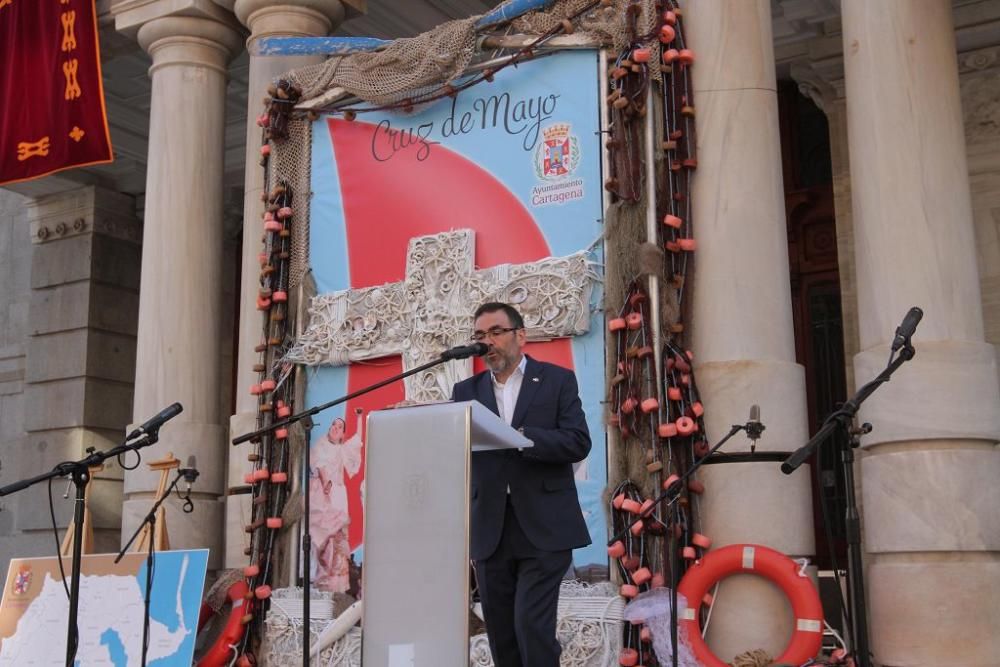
[677,544,823,667]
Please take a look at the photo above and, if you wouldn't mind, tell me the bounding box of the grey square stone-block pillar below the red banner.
[3,186,142,557]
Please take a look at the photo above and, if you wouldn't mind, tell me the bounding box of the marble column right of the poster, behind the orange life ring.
[683,0,815,661]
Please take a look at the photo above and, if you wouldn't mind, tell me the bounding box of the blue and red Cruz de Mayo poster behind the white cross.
[307,50,607,582]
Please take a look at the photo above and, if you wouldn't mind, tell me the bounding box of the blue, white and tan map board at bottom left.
[0,549,208,667]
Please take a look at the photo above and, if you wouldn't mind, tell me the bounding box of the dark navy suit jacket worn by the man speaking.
[452,357,590,560]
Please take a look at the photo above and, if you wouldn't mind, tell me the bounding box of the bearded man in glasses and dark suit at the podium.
[452,303,590,667]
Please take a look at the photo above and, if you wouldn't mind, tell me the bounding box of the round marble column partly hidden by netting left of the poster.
[225,0,354,567]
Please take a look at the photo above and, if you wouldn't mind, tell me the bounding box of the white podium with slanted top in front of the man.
[361,401,531,667]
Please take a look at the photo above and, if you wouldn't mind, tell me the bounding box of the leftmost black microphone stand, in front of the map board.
[0,426,160,667]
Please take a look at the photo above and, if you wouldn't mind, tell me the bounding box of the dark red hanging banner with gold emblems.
[0,0,112,183]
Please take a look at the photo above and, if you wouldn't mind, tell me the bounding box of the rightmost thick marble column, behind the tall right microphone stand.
[842,0,1000,666]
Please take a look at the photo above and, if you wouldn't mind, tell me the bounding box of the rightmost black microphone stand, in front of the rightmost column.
[781,338,916,667]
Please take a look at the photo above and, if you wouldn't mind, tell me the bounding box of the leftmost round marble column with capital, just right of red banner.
[115,3,242,569]
